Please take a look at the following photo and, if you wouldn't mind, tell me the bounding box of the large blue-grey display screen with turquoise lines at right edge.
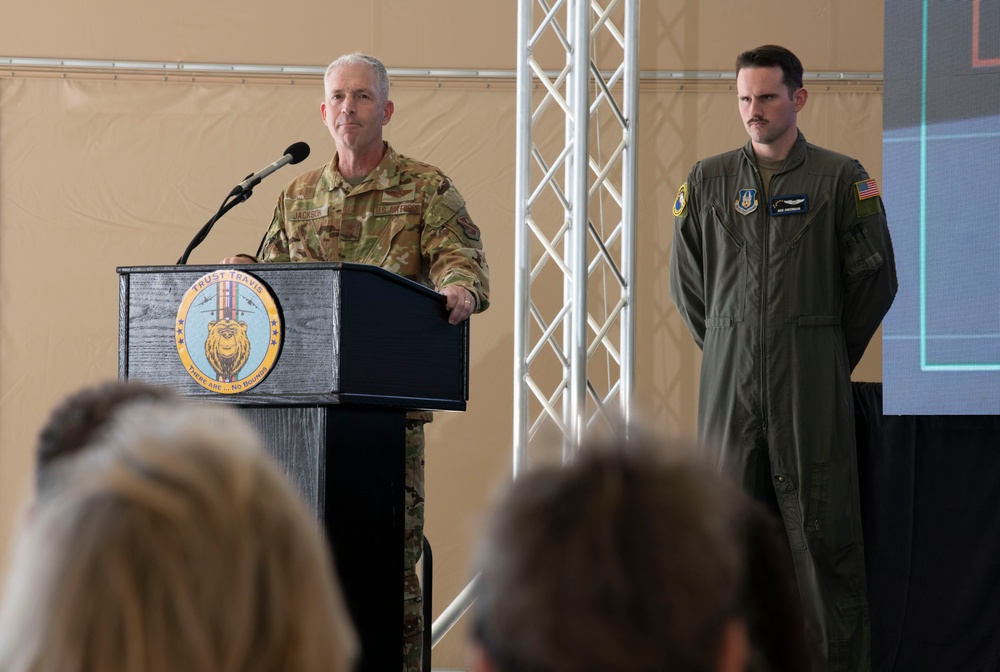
[883,0,1000,415]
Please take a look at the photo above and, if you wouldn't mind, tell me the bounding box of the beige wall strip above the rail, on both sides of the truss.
[0,0,882,72]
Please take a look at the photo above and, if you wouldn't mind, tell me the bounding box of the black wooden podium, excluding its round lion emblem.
[118,263,469,672]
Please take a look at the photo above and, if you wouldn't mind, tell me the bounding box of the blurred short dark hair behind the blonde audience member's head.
[35,380,180,499]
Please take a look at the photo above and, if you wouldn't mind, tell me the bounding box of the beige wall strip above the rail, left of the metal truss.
[0,0,517,70]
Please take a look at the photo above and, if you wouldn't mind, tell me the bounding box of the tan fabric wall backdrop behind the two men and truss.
[0,0,892,668]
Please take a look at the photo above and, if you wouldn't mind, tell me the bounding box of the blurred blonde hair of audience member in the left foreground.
[0,403,357,672]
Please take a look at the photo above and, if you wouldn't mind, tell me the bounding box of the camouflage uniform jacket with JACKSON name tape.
[257,143,490,313]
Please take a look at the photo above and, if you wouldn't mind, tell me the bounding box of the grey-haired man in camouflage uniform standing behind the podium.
[223,54,489,672]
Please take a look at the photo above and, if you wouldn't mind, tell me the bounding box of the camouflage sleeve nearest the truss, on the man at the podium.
[420,178,490,313]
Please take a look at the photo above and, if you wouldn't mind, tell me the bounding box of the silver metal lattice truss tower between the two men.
[514,0,639,475]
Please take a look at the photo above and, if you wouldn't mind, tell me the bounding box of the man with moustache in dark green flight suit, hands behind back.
[670,45,897,671]
